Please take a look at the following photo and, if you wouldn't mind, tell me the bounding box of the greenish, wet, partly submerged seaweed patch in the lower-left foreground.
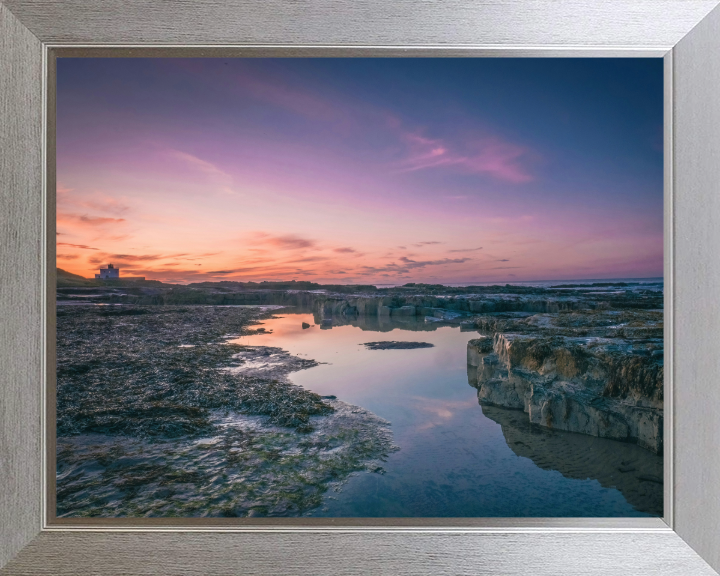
[57,400,396,517]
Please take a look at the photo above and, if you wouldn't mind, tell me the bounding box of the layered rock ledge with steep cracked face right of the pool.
[468,310,664,454]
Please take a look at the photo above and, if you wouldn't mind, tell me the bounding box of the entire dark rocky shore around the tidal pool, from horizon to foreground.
[58,282,664,516]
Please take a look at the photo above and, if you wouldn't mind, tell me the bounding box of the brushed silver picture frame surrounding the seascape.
[0,0,720,576]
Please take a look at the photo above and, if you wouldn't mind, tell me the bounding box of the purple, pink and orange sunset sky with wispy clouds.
[57,58,663,284]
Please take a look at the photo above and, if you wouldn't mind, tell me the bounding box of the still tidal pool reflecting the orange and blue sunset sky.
[233,310,662,517]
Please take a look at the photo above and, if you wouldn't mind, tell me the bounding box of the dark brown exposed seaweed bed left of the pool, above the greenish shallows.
[57,306,332,438]
